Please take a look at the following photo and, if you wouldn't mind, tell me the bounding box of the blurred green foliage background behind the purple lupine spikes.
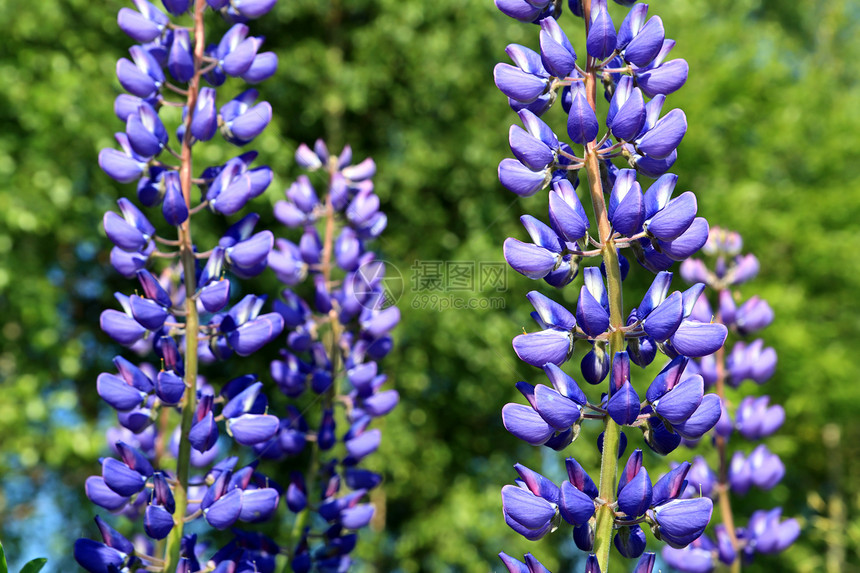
[0,0,860,573]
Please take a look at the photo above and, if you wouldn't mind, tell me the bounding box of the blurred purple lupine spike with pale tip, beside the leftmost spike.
[268,141,400,572]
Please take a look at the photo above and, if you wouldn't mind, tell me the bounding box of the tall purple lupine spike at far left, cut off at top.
[74,0,289,573]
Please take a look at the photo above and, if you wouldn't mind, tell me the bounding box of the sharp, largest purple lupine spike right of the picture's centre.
[494,0,736,572]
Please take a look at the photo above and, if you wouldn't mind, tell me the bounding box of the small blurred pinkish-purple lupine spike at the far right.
[663,228,800,573]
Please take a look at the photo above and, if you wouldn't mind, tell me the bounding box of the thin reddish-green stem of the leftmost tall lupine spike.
[163,0,206,571]
